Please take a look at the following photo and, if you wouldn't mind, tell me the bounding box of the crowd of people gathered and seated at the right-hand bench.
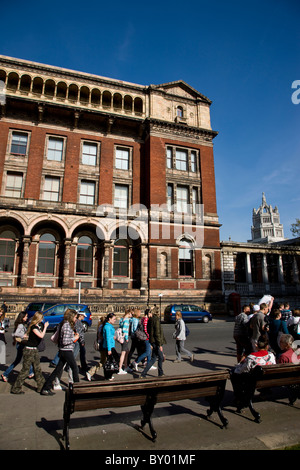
[233,296,300,374]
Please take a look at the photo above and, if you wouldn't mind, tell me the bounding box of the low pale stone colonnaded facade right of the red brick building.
[221,238,300,310]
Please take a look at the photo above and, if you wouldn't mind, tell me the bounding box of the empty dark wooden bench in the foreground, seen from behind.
[63,370,230,450]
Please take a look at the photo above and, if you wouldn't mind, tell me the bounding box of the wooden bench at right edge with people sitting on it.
[231,364,300,423]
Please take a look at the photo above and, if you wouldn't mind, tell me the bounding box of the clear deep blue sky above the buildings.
[0,0,300,241]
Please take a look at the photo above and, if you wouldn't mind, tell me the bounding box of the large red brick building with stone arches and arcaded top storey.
[0,56,222,309]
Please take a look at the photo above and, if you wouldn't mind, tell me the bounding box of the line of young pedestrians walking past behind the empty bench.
[0,307,194,395]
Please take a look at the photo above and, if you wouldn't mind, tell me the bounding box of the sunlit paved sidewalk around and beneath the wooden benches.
[0,346,300,453]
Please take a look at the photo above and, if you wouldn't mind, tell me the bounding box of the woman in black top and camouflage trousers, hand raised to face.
[11,312,49,394]
